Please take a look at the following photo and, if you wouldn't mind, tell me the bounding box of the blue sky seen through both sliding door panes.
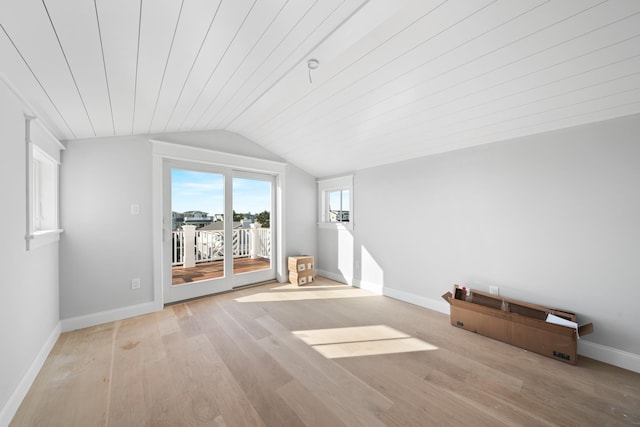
[171,169,271,215]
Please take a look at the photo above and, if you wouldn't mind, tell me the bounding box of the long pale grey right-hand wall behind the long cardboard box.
[318,116,640,370]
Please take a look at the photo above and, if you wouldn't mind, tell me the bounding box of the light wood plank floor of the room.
[12,278,640,427]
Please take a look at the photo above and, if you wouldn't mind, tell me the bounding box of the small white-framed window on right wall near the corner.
[318,175,354,228]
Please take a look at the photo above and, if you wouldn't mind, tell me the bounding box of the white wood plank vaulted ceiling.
[0,0,640,176]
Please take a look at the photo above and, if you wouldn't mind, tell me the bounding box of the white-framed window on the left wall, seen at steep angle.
[25,115,64,251]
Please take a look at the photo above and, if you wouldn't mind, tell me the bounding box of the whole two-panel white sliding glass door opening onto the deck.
[162,159,275,303]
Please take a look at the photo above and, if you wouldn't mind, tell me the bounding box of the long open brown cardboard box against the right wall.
[443,288,593,365]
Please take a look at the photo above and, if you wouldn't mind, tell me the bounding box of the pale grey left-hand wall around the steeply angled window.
[0,79,60,426]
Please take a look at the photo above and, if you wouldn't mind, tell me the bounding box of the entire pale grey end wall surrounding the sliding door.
[60,131,316,328]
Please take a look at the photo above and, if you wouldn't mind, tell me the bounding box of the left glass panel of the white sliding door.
[163,159,233,303]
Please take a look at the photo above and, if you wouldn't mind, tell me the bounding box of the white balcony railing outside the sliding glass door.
[171,228,271,266]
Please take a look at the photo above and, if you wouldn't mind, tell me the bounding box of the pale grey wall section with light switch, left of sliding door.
[60,137,153,319]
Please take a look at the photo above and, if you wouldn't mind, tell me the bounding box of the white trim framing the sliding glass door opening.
[150,139,287,310]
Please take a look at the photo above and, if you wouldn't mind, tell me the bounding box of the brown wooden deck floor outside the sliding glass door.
[171,258,271,285]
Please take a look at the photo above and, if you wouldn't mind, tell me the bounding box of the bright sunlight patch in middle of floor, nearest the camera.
[293,325,438,359]
